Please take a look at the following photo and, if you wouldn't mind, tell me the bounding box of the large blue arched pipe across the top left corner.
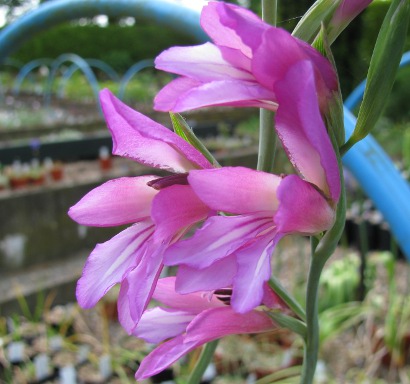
[0,0,209,62]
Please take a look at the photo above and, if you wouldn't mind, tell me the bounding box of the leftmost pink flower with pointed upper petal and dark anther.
[69,90,212,332]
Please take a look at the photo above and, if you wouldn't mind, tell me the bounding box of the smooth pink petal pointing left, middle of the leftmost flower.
[68,176,158,227]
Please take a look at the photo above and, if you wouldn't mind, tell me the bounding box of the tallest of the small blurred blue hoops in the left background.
[44,53,100,107]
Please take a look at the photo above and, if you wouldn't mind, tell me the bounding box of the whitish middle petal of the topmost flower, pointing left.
[155,43,253,82]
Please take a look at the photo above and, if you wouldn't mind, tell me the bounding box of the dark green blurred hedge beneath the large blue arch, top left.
[8,23,195,72]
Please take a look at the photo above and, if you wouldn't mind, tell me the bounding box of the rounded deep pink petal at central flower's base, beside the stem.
[274,175,335,235]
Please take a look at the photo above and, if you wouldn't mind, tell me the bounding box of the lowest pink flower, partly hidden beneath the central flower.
[134,277,287,380]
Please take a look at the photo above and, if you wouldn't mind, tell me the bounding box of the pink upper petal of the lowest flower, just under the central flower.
[152,276,224,313]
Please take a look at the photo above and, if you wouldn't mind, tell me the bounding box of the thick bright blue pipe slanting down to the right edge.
[343,108,410,261]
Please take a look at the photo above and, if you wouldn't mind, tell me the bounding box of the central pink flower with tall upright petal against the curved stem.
[164,61,340,313]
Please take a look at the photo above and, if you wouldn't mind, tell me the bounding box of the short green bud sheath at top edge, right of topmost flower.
[292,0,341,43]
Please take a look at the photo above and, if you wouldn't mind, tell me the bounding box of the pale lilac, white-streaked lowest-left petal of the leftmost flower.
[76,222,154,308]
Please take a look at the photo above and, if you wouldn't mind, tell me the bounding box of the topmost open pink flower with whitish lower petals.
[155,1,337,112]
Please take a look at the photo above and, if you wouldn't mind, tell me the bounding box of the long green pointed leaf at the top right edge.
[341,0,410,153]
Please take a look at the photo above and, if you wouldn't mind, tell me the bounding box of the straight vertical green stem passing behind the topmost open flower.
[257,0,278,172]
